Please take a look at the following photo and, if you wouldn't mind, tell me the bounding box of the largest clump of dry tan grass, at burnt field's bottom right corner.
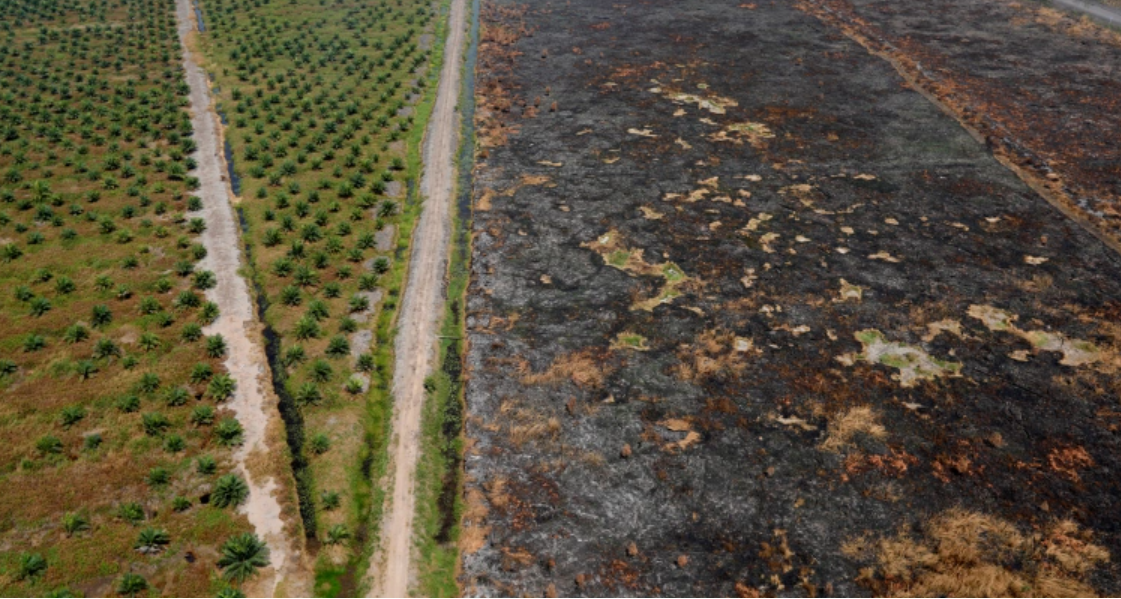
[841,508,1110,597]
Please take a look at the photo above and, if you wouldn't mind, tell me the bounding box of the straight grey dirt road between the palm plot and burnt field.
[367,0,466,597]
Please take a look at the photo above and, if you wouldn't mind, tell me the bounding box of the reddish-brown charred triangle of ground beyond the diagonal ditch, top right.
[799,0,1121,247]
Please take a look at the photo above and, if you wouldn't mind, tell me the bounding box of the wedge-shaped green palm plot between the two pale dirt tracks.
[203,0,433,558]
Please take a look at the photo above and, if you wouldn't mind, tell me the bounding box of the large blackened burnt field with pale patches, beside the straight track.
[462,0,1121,597]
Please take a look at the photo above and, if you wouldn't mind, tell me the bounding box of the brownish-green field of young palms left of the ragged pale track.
[0,0,254,596]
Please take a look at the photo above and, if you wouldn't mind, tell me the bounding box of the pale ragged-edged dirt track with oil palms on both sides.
[175,0,298,597]
